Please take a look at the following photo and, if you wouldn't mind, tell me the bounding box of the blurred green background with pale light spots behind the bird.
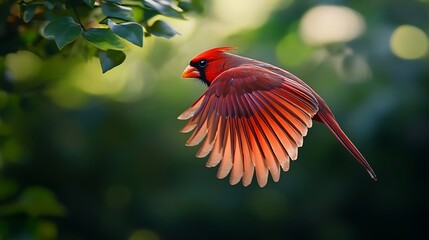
[0,0,429,240]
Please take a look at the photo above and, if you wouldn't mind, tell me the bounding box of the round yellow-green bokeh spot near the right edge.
[390,25,428,60]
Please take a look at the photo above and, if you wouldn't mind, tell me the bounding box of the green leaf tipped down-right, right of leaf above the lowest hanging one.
[107,19,143,47]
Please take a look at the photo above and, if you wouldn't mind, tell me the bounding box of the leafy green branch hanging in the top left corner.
[6,0,202,73]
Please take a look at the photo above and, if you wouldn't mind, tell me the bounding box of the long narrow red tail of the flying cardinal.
[313,96,377,181]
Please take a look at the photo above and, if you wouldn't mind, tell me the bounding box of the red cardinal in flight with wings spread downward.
[178,47,377,187]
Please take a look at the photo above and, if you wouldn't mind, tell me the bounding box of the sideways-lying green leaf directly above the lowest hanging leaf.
[82,28,125,50]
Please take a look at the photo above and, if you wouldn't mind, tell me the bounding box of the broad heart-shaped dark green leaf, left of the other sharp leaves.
[43,16,82,50]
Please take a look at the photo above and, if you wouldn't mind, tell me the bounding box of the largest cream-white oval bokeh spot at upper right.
[300,6,365,45]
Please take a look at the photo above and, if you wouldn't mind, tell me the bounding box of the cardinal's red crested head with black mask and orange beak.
[182,47,237,86]
